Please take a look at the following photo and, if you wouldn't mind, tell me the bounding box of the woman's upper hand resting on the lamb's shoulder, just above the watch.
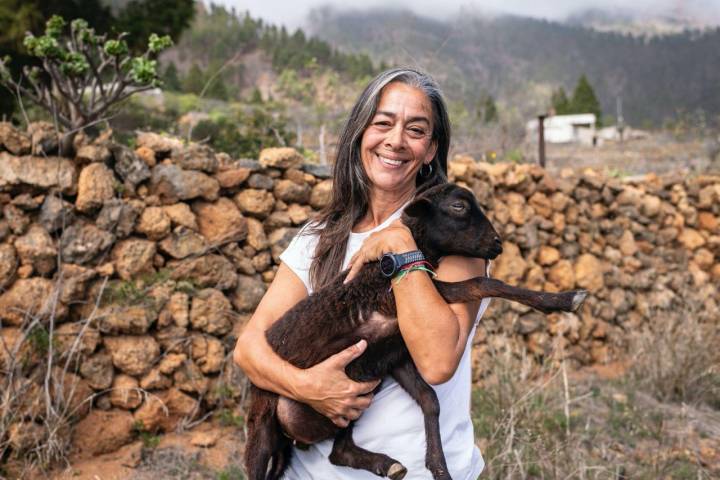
[344,219,417,283]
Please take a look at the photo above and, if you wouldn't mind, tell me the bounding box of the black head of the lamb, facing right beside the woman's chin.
[402,183,502,263]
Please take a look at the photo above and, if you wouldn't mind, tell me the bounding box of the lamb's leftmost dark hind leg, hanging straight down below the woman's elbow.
[245,385,283,480]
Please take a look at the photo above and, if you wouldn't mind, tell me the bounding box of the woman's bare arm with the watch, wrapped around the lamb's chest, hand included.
[346,221,485,385]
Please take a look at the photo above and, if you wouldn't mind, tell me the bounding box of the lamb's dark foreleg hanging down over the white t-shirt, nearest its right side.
[392,362,451,480]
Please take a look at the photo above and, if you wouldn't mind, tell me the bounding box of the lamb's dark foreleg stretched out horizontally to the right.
[434,277,587,313]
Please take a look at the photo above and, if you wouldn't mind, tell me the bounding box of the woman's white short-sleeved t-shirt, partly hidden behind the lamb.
[280,208,490,480]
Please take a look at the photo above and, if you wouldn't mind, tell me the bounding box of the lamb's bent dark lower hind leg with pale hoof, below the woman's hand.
[330,423,407,480]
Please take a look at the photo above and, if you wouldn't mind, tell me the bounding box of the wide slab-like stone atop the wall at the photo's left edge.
[0,152,77,195]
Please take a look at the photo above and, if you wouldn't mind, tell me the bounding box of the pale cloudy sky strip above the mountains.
[214,0,720,27]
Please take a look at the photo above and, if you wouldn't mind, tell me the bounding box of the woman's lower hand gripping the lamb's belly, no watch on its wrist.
[297,340,380,428]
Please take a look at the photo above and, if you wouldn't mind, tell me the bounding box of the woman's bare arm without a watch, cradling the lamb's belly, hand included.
[233,263,378,426]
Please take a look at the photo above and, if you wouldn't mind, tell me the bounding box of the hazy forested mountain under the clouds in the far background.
[307,8,720,125]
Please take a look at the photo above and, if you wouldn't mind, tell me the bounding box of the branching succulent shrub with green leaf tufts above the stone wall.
[0,15,172,155]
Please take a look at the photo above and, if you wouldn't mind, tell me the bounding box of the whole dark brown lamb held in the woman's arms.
[245,184,585,480]
